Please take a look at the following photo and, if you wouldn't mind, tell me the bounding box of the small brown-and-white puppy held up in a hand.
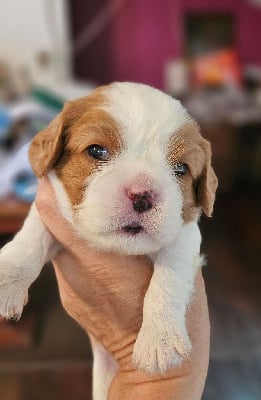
[0,83,217,400]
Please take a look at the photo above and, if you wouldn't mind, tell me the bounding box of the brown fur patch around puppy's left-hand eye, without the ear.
[55,109,121,205]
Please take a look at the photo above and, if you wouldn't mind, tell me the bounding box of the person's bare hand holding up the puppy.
[36,179,209,400]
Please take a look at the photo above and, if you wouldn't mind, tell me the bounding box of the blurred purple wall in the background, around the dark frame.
[112,0,261,88]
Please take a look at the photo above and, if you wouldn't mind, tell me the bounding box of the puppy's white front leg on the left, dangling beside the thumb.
[0,204,58,319]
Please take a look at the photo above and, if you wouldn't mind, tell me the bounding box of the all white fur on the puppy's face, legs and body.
[0,83,201,400]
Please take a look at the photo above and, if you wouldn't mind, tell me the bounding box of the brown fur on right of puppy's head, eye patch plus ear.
[168,120,217,223]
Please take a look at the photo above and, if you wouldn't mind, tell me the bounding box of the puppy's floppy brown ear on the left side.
[29,113,63,178]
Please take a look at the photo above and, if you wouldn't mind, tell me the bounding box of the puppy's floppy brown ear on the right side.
[195,139,218,217]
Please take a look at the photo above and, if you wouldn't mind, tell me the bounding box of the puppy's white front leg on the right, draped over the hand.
[133,223,202,374]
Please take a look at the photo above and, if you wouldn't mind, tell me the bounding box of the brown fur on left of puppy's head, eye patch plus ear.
[29,87,121,205]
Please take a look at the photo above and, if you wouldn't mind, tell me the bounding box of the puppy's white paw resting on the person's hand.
[133,325,191,374]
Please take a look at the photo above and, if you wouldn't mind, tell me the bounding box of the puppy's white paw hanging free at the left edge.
[0,260,28,320]
